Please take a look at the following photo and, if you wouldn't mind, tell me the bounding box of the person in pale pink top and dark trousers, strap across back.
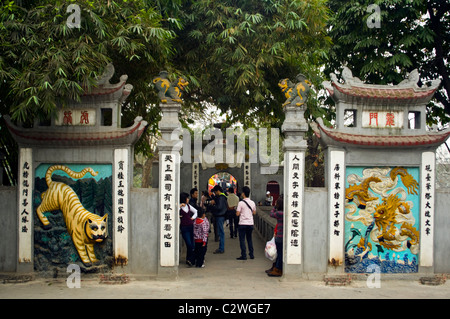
[236,186,256,260]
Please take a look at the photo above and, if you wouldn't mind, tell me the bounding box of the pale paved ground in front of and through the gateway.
[0,228,450,305]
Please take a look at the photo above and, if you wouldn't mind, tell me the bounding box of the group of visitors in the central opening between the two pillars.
[180,185,283,276]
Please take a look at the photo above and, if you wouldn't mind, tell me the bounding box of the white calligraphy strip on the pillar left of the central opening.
[159,152,180,267]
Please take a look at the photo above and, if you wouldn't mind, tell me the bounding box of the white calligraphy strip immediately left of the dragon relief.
[328,151,345,265]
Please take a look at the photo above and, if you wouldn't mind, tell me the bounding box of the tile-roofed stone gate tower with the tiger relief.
[5,65,147,273]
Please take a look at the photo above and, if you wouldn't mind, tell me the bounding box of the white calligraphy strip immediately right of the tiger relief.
[113,148,129,264]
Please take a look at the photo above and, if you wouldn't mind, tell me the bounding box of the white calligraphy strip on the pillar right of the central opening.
[284,152,305,264]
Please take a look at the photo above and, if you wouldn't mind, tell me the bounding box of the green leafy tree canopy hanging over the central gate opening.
[174,0,330,129]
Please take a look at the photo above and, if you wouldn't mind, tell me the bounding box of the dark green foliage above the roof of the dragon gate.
[326,0,450,123]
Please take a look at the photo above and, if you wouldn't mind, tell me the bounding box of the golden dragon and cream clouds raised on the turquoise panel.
[345,167,420,272]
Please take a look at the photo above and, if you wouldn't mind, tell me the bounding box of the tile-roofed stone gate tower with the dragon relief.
[313,68,450,273]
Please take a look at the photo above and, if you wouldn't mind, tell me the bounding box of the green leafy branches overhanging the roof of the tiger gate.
[0,0,175,122]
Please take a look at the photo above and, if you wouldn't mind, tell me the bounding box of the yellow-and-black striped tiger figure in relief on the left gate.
[36,165,108,267]
